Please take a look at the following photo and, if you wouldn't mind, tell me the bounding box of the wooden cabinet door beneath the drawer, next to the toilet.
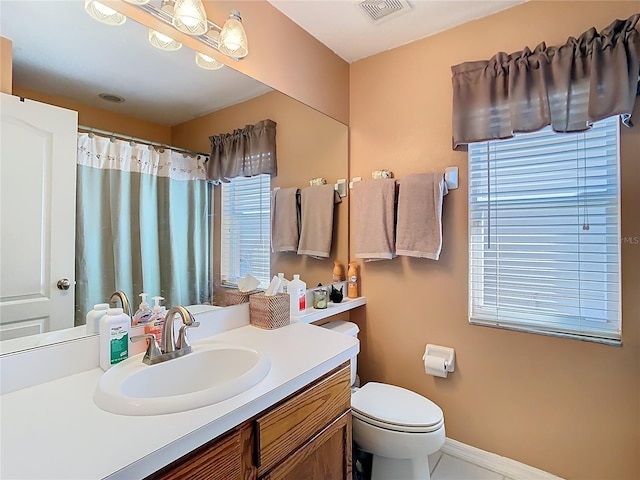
[261,411,351,480]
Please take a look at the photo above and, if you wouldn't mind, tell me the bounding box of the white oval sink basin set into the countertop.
[94,344,271,415]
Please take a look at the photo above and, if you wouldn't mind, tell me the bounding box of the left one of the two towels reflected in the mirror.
[271,188,300,252]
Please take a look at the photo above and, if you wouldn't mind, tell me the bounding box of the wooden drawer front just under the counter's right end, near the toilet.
[256,364,351,475]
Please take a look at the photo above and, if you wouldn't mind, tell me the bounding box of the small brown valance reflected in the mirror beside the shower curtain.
[205,120,278,182]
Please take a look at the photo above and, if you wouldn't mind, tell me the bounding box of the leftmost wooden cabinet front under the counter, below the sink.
[147,431,243,480]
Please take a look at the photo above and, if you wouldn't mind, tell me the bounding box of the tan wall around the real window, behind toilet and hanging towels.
[350,1,640,480]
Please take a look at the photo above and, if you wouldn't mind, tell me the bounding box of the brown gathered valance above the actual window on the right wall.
[451,14,640,150]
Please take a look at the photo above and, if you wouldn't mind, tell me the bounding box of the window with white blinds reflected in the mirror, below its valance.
[220,175,271,288]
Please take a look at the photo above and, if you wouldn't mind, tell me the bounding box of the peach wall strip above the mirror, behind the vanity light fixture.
[109,0,349,124]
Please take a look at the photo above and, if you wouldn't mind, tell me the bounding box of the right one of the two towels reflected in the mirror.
[298,185,342,258]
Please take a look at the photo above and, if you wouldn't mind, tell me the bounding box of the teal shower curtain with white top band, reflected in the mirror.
[76,133,212,325]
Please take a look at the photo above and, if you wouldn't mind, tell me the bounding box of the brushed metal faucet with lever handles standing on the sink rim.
[131,306,200,365]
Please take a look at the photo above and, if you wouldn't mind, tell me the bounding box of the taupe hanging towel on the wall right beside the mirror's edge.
[351,178,396,260]
